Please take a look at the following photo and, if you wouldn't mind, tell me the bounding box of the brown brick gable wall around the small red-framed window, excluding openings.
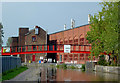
[25,27,46,62]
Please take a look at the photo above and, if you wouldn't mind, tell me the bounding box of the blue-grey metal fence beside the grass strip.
[0,56,21,72]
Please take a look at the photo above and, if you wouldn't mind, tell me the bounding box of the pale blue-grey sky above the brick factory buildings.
[2,2,101,45]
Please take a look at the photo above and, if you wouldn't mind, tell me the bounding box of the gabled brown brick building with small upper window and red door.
[25,26,47,62]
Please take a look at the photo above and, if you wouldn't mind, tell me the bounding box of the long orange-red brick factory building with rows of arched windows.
[49,24,95,64]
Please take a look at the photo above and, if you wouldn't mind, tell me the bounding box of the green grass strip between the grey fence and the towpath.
[2,66,28,81]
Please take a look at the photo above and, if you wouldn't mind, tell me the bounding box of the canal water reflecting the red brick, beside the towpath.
[38,67,120,81]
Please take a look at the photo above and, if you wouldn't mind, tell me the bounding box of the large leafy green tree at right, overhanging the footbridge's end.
[86,2,119,65]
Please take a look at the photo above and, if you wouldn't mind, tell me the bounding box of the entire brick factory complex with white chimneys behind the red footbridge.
[5,17,98,64]
